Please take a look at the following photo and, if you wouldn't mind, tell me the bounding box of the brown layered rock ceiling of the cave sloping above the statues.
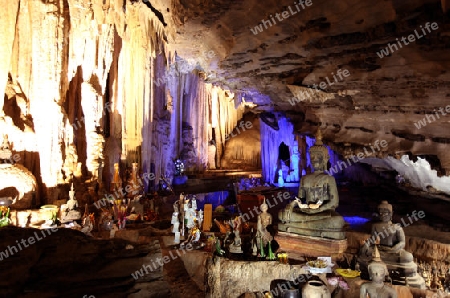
[154,0,450,169]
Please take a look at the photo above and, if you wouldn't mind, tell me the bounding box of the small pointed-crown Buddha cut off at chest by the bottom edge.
[359,247,397,298]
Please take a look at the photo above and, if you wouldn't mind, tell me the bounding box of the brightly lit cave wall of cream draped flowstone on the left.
[0,0,244,204]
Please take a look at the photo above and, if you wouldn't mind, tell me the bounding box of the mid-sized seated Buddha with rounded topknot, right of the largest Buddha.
[357,201,425,288]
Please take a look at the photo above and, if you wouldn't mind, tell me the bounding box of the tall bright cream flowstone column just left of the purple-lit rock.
[113,2,166,182]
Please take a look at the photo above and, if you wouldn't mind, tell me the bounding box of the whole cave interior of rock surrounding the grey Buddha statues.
[0,0,450,298]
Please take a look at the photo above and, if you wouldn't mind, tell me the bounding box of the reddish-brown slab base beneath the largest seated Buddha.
[275,232,347,260]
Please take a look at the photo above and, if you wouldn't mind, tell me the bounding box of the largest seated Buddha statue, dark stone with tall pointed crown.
[278,130,345,239]
